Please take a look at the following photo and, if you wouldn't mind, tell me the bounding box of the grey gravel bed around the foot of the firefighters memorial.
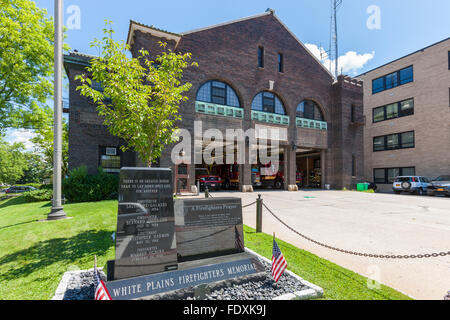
[64,261,309,300]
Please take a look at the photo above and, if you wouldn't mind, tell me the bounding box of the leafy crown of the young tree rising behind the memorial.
[76,22,197,167]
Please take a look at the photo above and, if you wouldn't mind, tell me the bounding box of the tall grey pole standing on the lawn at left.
[47,0,67,220]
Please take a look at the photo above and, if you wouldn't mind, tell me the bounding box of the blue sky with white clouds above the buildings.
[7,0,450,148]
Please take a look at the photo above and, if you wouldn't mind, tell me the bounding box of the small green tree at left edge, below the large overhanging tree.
[0,138,28,184]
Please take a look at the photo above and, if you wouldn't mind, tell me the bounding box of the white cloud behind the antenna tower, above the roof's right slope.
[305,43,375,75]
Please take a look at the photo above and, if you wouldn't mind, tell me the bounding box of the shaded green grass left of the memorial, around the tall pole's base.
[0,197,117,300]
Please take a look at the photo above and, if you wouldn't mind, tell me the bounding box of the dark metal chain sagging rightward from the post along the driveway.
[263,203,450,259]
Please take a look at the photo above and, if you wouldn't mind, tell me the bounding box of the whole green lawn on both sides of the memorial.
[0,198,414,300]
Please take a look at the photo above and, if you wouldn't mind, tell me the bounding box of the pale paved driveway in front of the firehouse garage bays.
[205,191,450,299]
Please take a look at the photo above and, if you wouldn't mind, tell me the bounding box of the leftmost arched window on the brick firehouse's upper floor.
[197,80,241,108]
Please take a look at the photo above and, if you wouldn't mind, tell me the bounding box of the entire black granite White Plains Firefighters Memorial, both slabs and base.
[106,168,265,300]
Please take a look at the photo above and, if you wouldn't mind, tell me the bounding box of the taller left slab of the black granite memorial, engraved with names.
[108,168,178,280]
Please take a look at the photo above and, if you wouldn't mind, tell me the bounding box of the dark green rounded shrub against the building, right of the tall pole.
[63,166,119,202]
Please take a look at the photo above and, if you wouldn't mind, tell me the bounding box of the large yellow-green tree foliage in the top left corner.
[0,0,54,131]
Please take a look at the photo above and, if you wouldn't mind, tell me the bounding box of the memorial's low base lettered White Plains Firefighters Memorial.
[106,252,266,300]
